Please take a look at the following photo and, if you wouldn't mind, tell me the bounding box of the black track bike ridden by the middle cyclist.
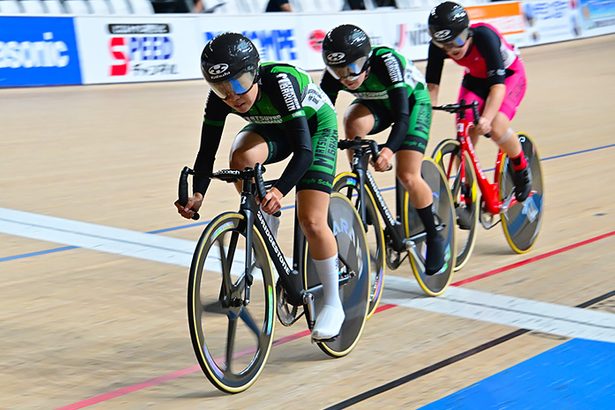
[333,138,455,317]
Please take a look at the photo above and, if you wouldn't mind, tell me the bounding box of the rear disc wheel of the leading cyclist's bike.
[302,192,370,357]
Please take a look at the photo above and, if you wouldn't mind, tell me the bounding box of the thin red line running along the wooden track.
[57,231,615,410]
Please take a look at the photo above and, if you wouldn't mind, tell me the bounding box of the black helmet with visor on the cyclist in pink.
[427,1,470,47]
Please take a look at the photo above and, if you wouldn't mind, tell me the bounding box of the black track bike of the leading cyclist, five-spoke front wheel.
[179,164,369,393]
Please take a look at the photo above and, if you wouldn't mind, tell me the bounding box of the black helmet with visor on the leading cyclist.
[201,33,260,98]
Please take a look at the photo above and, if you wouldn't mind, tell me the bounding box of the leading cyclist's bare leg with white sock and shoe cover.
[297,189,345,339]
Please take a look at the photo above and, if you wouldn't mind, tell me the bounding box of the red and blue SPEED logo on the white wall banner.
[107,24,178,77]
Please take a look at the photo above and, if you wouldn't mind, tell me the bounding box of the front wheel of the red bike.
[433,139,480,271]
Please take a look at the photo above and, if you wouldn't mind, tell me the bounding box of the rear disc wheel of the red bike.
[498,134,544,254]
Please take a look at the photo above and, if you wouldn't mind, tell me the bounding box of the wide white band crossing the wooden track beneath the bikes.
[0,208,615,342]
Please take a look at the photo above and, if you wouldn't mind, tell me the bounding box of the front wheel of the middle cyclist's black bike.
[333,172,386,319]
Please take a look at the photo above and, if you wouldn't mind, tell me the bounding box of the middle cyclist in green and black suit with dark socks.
[320,24,446,275]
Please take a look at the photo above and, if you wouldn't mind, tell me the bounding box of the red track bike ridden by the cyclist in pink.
[433,100,544,270]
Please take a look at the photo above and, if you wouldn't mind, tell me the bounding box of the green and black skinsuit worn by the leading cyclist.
[194,63,337,195]
